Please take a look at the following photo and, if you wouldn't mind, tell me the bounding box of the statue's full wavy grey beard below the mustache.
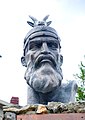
[24,55,62,93]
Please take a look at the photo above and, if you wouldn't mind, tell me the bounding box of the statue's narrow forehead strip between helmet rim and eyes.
[29,37,59,43]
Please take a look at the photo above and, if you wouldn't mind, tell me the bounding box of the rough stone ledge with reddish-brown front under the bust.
[3,102,85,120]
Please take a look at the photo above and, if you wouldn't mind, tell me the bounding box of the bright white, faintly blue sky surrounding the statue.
[0,0,85,106]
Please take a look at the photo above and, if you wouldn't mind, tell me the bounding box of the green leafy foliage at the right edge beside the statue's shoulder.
[75,62,85,101]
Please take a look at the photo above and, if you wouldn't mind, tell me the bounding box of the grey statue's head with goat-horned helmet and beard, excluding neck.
[21,16,63,93]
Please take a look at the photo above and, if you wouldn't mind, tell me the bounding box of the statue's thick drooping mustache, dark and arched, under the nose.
[35,53,56,68]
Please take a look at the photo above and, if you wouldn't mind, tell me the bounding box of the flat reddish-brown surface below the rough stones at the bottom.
[17,113,85,120]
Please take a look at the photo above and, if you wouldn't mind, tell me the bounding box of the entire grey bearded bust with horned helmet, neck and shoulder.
[21,15,77,104]
